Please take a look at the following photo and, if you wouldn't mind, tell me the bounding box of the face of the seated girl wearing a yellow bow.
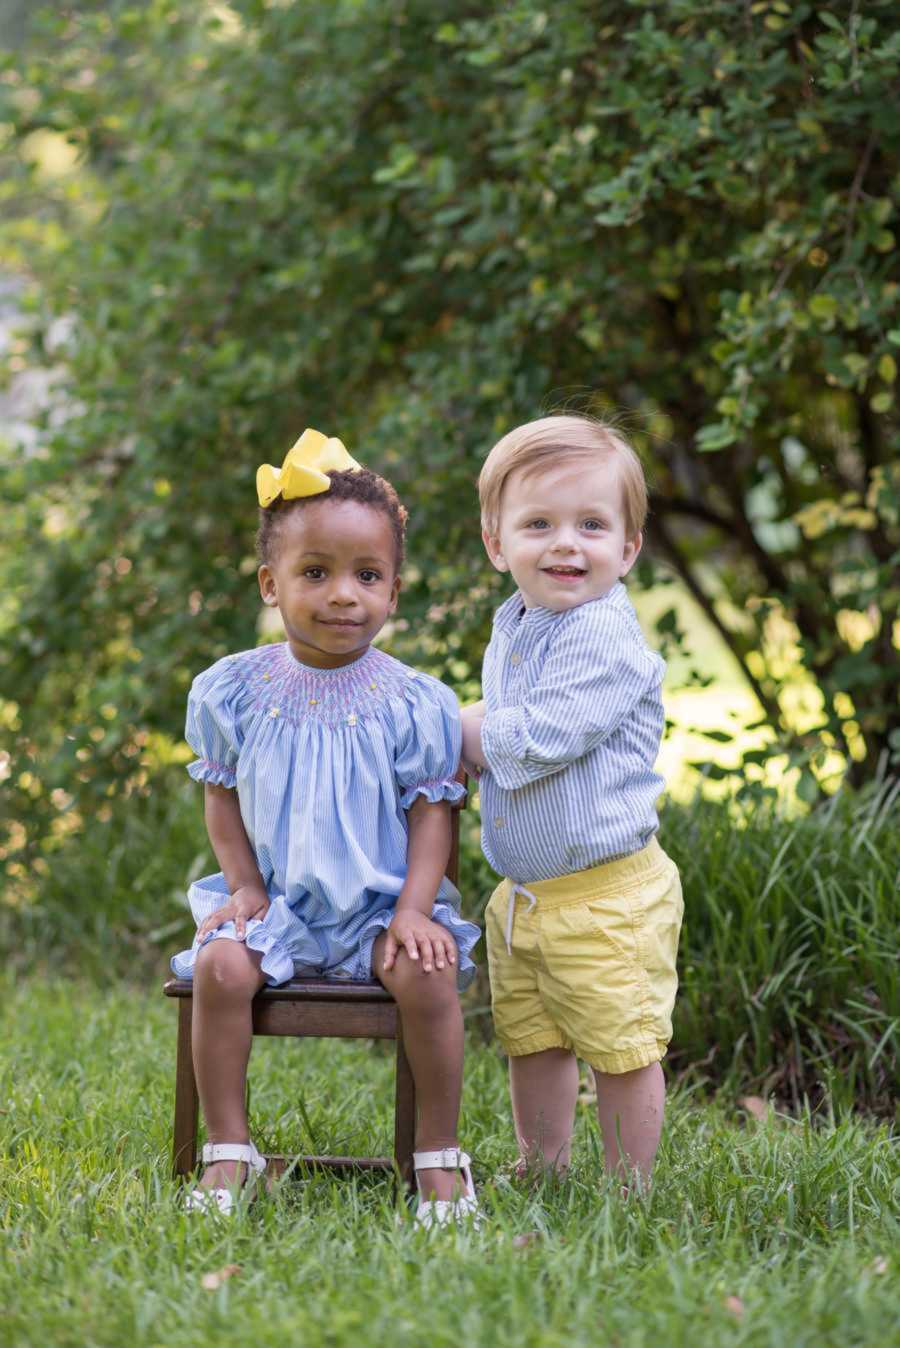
[259,496,400,669]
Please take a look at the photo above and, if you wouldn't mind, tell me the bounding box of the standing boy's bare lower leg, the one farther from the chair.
[594,1062,666,1185]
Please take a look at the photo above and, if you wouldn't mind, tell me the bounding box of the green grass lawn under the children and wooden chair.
[0,977,900,1348]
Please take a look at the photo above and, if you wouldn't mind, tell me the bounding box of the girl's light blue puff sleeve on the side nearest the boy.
[393,674,466,810]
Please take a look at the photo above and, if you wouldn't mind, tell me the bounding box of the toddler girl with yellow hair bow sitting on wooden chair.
[172,430,478,1227]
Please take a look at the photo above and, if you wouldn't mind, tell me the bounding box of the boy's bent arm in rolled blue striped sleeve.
[476,619,659,791]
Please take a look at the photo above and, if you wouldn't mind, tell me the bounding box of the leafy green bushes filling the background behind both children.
[0,0,900,879]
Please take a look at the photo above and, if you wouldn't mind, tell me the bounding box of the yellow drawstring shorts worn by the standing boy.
[485,838,684,1073]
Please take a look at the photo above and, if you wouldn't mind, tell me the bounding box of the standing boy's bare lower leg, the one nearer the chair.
[509,1049,578,1174]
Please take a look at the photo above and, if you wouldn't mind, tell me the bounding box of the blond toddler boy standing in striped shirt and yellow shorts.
[462,415,683,1181]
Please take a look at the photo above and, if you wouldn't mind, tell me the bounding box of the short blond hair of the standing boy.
[478,414,647,538]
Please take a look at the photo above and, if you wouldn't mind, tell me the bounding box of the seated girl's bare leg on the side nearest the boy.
[372,934,462,1198]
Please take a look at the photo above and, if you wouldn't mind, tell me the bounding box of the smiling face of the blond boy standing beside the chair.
[482,456,641,613]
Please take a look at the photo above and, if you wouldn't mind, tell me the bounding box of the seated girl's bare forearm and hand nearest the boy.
[384,795,457,973]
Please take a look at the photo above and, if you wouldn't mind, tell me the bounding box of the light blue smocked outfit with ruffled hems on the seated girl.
[171,643,480,987]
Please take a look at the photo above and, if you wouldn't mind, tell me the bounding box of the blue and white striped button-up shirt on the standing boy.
[481,582,666,884]
